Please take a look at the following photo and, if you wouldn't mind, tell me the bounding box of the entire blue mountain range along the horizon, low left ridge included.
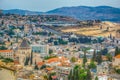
[3,6,120,22]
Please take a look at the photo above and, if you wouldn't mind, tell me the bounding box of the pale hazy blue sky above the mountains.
[0,0,120,11]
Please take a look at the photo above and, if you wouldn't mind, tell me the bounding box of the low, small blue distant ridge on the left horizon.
[3,9,43,15]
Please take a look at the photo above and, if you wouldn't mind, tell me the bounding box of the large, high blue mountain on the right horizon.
[47,6,120,22]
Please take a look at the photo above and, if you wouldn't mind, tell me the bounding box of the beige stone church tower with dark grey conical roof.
[18,38,31,65]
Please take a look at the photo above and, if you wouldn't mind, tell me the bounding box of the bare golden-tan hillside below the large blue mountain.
[61,21,120,37]
